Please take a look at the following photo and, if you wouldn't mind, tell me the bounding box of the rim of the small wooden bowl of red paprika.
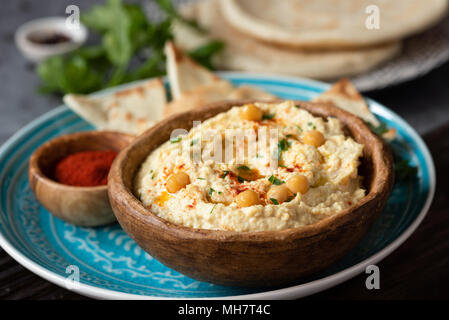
[28,130,134,192]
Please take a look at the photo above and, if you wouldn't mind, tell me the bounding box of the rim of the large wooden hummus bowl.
[108,99,394,242]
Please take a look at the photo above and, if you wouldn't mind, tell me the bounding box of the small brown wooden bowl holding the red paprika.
[28,131,135,227]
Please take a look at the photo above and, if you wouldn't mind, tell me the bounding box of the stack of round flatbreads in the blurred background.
[174,0,448,80]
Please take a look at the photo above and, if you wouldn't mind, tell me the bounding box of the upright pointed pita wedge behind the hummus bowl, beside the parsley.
[164,42,276,116]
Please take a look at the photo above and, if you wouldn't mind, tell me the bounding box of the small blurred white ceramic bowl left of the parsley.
[15,17,88,62]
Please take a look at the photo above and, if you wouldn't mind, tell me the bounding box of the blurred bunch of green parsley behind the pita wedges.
[37,0,218,94]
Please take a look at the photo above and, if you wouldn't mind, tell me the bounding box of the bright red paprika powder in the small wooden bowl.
[54,150,118,187]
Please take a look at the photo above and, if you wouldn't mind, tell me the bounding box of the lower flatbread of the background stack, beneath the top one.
[173,0,401,80]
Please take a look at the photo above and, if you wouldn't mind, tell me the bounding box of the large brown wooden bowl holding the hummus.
[108,100,394,286]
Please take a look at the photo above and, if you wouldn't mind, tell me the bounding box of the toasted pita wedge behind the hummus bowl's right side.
[312,78,380,127]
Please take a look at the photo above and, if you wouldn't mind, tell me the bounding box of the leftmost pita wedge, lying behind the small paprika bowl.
[64,79,167,135]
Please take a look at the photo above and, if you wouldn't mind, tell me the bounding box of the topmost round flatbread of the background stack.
[220,0,448,49]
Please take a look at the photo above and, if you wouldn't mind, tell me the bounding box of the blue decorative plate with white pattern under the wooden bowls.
[0,73,435,299]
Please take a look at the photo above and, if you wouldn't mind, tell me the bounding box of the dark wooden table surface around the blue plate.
[0,123,449,299]
